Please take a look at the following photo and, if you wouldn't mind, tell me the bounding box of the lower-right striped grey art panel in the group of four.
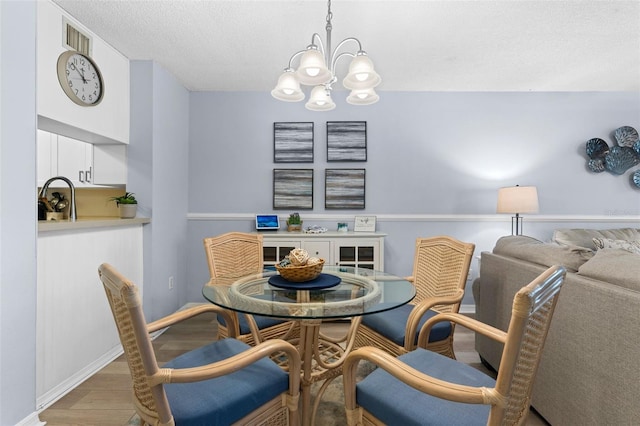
[324,169,365,209]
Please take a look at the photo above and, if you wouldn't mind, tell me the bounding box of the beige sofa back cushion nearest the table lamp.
[493,235,593,272]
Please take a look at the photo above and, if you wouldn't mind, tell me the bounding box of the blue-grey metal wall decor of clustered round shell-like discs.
[586,126,640,188]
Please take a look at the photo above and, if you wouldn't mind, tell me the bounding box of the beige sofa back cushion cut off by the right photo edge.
[578,248,640,291]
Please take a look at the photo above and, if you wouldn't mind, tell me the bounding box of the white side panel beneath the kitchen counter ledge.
[36,225,143,409]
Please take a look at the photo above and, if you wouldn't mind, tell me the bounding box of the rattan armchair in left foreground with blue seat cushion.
[98,263,301,425]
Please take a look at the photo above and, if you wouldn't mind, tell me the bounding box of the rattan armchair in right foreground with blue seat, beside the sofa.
[343,266,565,426]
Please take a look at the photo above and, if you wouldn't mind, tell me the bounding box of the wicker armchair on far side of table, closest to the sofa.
[356,236,475,359]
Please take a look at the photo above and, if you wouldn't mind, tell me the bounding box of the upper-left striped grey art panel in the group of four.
[273,122,313,163]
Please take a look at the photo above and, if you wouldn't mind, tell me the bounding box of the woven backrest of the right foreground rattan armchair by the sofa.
[488,266,566,425]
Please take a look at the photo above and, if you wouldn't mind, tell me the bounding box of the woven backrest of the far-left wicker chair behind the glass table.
[203,232,264,279]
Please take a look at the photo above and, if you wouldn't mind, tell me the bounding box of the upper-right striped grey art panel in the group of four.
[327,121,367,161]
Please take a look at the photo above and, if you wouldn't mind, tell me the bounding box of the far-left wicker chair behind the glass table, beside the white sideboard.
[203,232,300,346]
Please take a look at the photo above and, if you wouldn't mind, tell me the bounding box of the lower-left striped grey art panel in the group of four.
[273,169,313,209]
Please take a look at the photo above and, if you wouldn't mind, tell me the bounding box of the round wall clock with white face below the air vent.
[58,50,104,106]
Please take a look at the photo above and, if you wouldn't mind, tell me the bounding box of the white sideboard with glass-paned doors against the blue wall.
[263,232,386,271]
